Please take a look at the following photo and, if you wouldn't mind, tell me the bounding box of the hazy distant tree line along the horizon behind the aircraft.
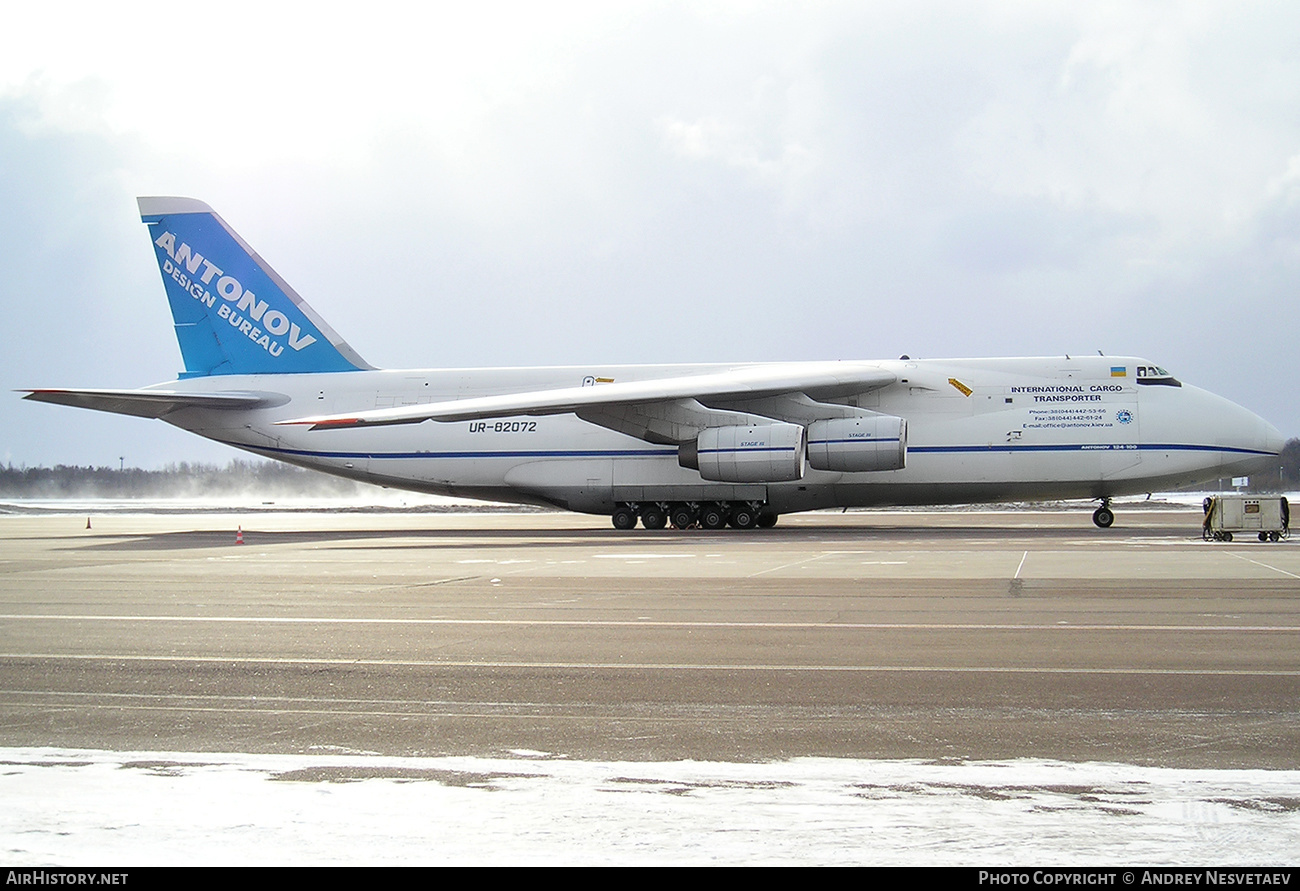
[0,438,1300,498]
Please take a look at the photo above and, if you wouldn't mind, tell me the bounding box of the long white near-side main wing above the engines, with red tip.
[280,362,897,429]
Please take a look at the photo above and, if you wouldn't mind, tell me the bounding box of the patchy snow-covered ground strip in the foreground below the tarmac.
[0,748,1300,866]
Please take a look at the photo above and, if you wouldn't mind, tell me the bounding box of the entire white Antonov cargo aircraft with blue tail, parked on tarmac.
[26,198,1282,529]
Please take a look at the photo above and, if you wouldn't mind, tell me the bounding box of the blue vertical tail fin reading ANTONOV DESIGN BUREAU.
[138,198,372,377]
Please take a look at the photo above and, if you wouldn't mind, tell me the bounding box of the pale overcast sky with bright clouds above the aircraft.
[0,0,1300,467]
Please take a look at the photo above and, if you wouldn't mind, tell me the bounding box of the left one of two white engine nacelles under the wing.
[677,424,805,483]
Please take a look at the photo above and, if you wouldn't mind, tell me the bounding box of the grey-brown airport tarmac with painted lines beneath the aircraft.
[0,509,1300,769]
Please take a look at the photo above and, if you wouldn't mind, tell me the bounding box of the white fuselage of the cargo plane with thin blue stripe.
[149,356,1281,514]
